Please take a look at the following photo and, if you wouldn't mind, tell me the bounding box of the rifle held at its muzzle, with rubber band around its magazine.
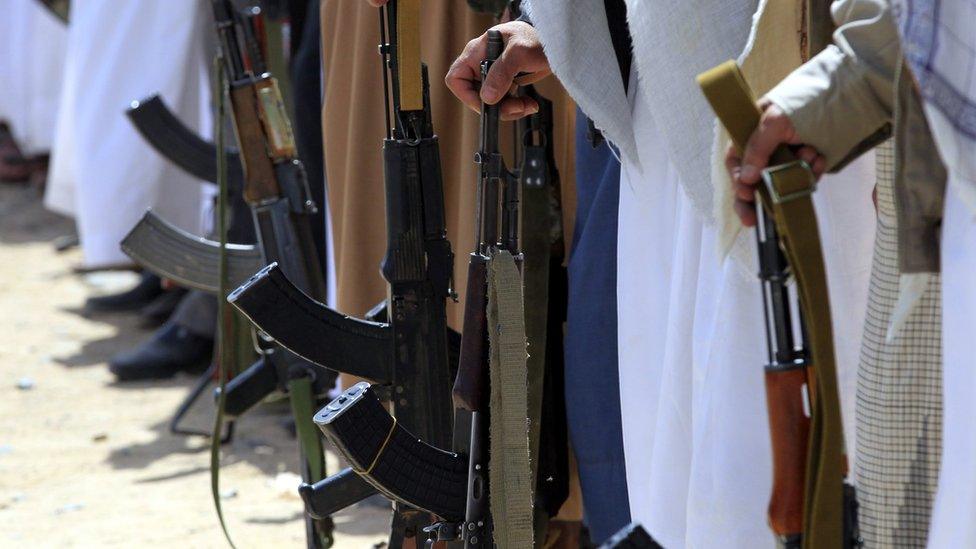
[315,31,539,548]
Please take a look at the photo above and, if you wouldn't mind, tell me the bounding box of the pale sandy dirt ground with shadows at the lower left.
[0,185,389,549]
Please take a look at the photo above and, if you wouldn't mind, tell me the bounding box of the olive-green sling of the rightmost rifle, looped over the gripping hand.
[698,61,845,548]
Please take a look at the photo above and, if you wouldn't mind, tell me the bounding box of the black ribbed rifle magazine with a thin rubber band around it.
[314,382,468,522]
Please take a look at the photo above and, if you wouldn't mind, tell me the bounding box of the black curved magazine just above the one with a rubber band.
[227,263,393,383]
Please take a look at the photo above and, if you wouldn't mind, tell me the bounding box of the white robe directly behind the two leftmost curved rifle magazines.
[45,0,212,267]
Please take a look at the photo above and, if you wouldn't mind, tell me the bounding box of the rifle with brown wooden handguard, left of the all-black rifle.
[211,0,335,548]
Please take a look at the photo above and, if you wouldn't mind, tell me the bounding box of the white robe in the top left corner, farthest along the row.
[0,0,68,154]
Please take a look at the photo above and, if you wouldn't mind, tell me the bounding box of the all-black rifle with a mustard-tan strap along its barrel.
[229,0,454,547]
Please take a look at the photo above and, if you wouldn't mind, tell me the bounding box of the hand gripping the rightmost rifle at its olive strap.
[725,98,825,227]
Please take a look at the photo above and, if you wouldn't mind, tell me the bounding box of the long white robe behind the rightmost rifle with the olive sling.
[617,75,874,549]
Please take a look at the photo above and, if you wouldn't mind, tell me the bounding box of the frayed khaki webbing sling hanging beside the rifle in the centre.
[488,250,533,547]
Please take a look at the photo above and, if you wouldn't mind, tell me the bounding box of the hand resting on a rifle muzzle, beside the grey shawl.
[446,22,551,120]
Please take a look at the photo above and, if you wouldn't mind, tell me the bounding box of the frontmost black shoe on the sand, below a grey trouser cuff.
[108,322,213,381]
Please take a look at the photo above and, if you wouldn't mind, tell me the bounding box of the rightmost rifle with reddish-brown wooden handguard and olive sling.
[698,61,860,549]
